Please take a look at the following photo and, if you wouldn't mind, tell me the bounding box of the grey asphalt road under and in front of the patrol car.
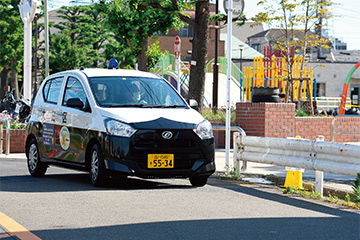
[0,159,360,240]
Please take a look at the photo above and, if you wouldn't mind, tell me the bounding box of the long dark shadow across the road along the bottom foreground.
[33,216,360,240]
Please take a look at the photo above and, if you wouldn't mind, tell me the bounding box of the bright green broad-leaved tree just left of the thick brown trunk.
[107,0,179,71]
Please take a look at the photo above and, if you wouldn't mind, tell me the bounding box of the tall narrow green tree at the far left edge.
[0,0,24,98]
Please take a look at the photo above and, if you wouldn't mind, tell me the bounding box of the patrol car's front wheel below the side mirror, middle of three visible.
[90,144,108,187]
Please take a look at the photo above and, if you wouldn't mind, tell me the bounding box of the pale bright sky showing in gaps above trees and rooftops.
[49,0,360,50]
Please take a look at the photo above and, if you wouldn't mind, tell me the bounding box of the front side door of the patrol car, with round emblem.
[55,75,92,163]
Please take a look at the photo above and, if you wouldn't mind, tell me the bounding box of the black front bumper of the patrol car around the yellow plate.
[103,129,215,178]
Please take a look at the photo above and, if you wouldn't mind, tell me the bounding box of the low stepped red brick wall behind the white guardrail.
[236,103,360,142]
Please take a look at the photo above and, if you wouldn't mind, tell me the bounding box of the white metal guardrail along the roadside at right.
[234,133,360,193]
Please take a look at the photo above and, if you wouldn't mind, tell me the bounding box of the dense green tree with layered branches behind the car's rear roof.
[49,1,112,72]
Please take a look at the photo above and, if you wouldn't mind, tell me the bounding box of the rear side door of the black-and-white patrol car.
[37,76,64,159]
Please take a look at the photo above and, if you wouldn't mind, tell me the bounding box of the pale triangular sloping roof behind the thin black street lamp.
[220,33,264,60]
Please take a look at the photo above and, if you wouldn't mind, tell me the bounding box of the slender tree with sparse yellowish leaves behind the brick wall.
[252,0,332,102]
